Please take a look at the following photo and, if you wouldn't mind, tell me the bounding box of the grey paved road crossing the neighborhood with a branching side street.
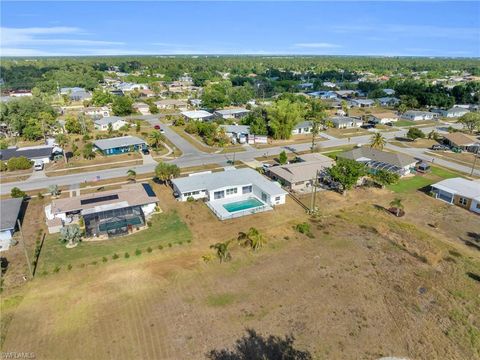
[0,120,480,194]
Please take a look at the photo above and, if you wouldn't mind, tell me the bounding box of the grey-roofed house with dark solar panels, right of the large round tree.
[337,146,417,176]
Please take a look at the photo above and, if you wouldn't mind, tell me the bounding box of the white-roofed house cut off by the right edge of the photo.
[431,177,480,214]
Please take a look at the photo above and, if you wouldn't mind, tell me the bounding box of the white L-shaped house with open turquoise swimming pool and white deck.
[172,168,287,220]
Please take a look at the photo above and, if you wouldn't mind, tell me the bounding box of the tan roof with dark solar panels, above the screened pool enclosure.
[52,183,158,214]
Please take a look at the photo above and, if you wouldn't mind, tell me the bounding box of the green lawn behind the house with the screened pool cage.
[37,212,192,274]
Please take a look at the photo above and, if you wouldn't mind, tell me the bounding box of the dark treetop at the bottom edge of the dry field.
[206,329,312,360]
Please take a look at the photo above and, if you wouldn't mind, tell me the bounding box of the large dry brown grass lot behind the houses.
[2,186,480,359]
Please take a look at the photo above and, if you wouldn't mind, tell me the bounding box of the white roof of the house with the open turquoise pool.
[172,168,287,196]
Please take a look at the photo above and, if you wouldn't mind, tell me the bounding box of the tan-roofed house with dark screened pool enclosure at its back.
[45,183,159,237]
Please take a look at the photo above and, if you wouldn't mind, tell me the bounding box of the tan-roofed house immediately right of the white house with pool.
[268,154,335,191]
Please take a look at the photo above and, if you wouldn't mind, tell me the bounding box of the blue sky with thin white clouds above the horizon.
[0,1,480,57]
